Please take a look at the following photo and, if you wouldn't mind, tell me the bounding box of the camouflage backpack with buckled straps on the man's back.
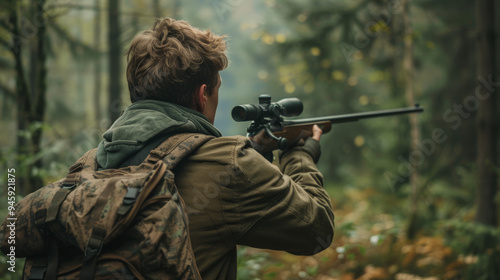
[0,134,212,279]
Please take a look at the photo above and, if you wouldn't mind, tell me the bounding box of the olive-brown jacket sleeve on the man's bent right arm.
[231,139,334,255]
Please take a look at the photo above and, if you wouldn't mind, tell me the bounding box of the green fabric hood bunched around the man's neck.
[97,100,222,169]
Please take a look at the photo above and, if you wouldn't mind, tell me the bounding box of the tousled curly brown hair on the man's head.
[127,18,228,108]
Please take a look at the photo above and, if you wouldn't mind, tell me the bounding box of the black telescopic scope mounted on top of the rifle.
[231,94,303,122]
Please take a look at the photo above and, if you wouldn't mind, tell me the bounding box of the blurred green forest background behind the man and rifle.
[0,0,500,280]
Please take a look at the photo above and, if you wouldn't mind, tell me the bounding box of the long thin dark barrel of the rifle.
[283,104,424,126]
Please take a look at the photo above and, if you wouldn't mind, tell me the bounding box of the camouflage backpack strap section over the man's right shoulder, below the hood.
[142,133,215,170]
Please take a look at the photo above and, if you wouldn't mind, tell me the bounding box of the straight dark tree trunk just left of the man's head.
[108,0,123,122]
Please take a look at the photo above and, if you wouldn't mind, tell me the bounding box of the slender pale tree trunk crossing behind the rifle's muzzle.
[402,0,421,239]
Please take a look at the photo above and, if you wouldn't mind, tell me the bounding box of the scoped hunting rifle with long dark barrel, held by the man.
[231,94,424,150]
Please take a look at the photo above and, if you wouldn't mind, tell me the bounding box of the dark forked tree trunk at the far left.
[4,0,48,194]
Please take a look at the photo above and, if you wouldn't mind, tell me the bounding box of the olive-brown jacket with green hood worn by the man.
[97,101,334,280]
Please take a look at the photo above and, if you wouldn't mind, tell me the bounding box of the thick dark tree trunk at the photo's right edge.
[475,0,498,226]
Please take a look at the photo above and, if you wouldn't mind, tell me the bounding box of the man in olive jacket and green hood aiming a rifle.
[97,18,334,279]
